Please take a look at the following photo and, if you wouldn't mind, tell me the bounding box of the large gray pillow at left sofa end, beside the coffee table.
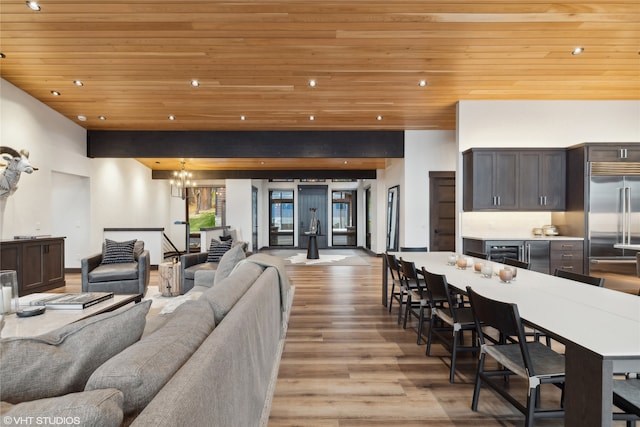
[0,300,151,403]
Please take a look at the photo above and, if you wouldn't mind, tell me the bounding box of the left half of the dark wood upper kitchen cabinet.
[463,149,518,211]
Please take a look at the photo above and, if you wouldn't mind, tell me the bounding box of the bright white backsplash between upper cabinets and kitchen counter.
[460,211,551,238]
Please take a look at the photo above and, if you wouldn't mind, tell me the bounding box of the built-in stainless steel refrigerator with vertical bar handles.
[587,162,640,276]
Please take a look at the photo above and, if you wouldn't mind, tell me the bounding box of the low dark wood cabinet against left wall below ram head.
[0,237,65,296]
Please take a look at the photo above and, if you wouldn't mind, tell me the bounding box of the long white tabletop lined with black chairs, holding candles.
[384,252,640,360]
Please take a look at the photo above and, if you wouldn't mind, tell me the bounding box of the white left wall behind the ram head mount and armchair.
[0,79,184,268]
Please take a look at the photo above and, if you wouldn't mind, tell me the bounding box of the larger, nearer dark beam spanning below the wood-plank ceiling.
[87,130,404,158]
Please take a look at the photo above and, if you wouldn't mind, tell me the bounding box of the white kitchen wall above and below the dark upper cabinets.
[456,101,640,249]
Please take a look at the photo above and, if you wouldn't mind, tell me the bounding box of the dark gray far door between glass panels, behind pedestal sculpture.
[298,185,329,249]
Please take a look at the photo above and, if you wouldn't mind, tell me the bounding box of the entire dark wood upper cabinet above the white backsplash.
[462,148,566,211]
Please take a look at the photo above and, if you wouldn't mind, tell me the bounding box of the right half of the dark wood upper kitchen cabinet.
[518,150,566,211]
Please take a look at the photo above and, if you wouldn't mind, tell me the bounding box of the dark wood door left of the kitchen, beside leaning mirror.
[429,172,456,251]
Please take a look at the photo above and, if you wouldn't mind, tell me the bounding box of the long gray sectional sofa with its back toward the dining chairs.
[0,251,293,427]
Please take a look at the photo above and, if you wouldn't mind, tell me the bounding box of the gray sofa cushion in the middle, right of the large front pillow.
[85,301,215,417]
